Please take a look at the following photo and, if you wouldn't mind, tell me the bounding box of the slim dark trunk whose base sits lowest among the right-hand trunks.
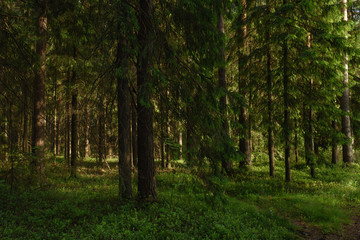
[283,0,291,182]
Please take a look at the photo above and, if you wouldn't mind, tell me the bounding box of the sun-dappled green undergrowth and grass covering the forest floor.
[0,155,360,239]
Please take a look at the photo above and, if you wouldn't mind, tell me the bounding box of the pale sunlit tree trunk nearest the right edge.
[341,0,353,163]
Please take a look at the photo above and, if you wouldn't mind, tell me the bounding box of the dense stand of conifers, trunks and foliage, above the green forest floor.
[0,0,360,239]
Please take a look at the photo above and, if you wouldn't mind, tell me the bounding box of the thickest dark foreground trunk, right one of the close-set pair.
[137,0,157,199]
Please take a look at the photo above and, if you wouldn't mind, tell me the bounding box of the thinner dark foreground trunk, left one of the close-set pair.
[116,36,132,198]
